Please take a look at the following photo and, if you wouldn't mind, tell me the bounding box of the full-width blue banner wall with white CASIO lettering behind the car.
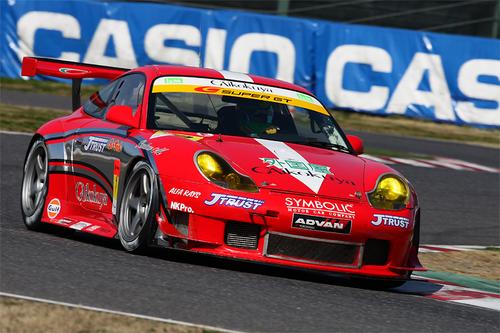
[0,0,500,127]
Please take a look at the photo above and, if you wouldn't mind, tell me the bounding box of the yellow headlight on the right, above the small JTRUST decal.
[368,175,410,210]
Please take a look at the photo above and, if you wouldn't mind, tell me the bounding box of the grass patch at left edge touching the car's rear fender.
[0,104,70,133]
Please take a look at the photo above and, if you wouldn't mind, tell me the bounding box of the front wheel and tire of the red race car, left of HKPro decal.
[118,161,158,253]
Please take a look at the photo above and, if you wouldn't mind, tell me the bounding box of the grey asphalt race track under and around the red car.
[0,92,500,332]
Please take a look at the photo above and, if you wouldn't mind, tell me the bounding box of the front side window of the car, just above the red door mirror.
[106,74,146,114]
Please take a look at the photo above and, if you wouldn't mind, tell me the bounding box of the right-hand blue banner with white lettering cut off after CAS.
[315,24,500,126]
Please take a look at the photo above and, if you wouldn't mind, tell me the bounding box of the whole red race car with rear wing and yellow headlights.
[21,58,422,286]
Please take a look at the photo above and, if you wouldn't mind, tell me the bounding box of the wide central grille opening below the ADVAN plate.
[266,233,360,266]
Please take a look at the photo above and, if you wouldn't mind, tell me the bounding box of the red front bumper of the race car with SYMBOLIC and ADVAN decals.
[158,179,421,279]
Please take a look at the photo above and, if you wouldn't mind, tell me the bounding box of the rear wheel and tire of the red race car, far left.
[21,139,49,230]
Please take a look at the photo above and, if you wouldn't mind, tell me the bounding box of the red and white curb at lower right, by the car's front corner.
[394,277,500,311]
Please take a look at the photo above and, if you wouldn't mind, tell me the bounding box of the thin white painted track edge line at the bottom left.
[0,291,241,333]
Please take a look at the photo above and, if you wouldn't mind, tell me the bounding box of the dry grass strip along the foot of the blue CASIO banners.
[0,78,500,146]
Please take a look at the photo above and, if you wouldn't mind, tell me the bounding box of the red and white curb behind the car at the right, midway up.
[360,154,500,173]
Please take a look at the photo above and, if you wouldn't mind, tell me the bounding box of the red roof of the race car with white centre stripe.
[134,65,312,95]
